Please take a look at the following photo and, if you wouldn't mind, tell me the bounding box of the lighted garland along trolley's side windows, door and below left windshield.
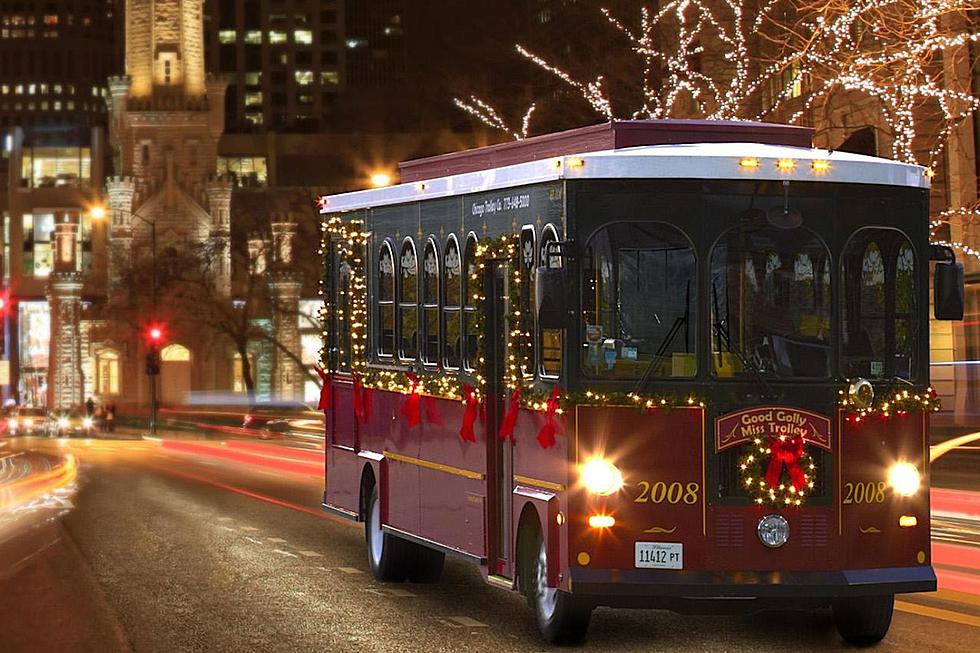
[319,216,704,414]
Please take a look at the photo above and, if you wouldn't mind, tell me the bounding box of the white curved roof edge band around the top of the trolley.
[320,143,929,213]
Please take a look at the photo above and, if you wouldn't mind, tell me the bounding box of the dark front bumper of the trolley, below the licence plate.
[568,565,936,605]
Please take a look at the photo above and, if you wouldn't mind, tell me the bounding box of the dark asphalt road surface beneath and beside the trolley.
[0,441,980,653]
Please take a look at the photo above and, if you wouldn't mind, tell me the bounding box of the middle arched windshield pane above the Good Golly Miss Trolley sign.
[708,224,831,379]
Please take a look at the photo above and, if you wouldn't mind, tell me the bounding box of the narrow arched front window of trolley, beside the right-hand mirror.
[841,229,918,380]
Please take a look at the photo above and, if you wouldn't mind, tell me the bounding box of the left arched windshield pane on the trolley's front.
[582,222,697,379]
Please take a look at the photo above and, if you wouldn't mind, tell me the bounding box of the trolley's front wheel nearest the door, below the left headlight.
[521,524,592,644]
